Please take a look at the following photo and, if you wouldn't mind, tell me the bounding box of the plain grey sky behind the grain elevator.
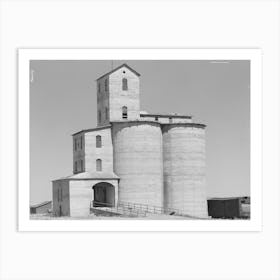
[30,61,250,204]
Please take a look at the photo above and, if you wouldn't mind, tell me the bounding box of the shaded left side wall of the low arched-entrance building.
[52,179,70,216]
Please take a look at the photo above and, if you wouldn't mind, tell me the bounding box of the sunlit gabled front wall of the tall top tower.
[109,67,140,121]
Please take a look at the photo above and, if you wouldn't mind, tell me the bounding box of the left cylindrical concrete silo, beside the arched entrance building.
[112,121,163,207]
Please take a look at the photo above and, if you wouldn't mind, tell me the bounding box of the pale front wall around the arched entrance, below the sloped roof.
[70,180,118,217]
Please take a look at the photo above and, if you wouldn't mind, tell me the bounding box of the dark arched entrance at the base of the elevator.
[92,183,115,207]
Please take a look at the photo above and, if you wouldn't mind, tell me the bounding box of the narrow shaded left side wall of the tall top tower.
[96,75,110,126]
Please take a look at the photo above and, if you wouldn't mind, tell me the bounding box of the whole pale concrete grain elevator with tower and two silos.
[53,66,207,217]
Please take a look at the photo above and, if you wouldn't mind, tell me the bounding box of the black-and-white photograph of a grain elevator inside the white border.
[29,60,251,220]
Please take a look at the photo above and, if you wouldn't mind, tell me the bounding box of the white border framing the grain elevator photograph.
[18,48,262,232]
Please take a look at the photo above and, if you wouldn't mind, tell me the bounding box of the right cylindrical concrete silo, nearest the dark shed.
[162,123,208,217]
